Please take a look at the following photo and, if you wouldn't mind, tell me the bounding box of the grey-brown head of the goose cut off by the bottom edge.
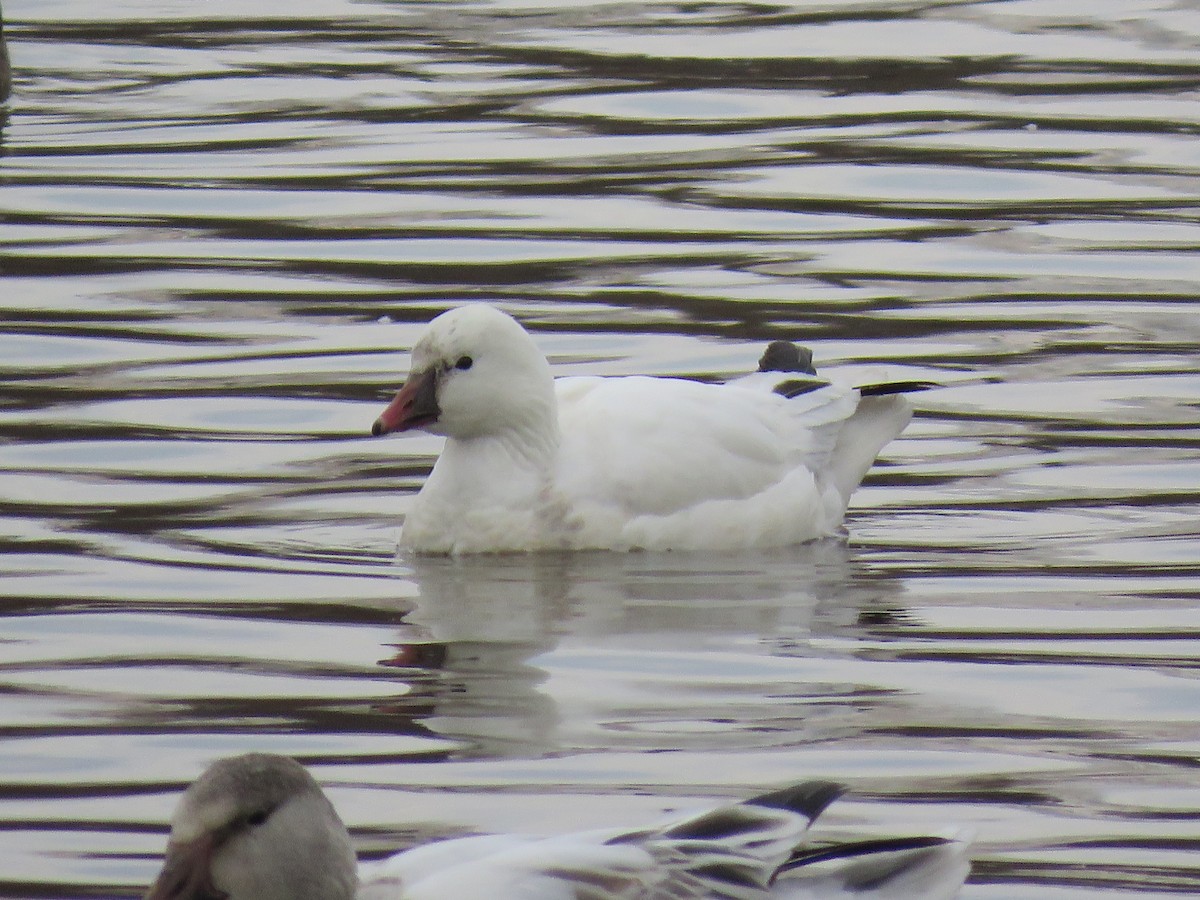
[145,754,358,900]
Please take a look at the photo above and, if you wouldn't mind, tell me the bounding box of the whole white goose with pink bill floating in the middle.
[372,304,928,553]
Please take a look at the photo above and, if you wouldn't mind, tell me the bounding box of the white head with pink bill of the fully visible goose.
[371,304,557,439]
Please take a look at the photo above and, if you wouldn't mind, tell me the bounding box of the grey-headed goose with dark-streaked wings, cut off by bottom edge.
[146,754,970,900]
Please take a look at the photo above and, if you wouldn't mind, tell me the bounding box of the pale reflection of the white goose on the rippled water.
[382,541,907,758]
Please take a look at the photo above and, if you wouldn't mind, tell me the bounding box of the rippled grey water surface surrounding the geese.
[0,0,1200,898]
